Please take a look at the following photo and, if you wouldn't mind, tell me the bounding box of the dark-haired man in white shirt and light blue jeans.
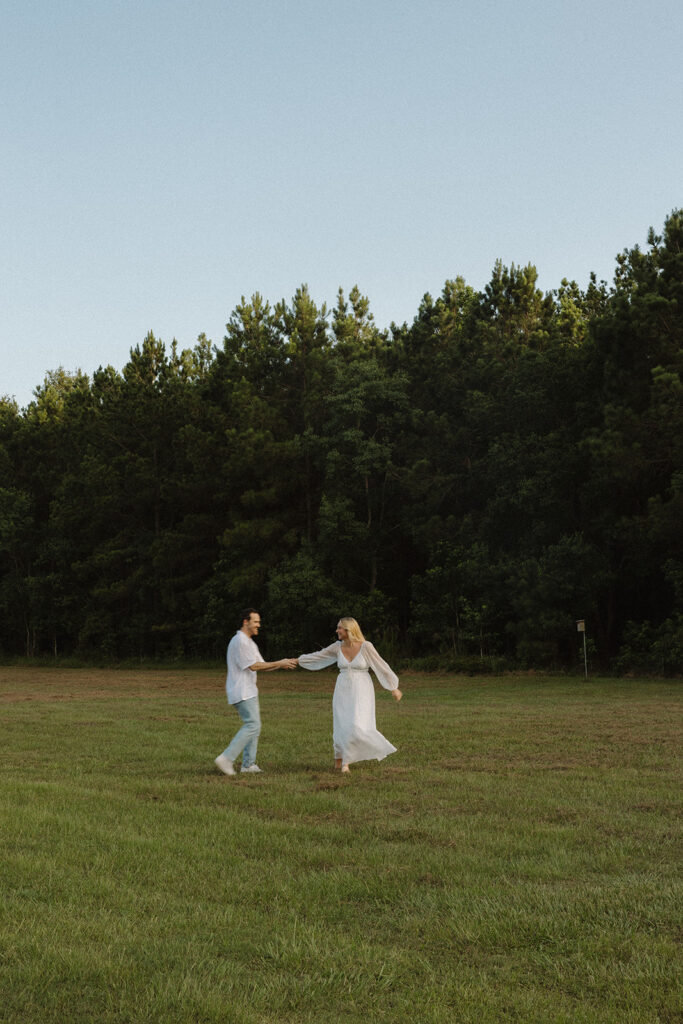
[215,608,297,775]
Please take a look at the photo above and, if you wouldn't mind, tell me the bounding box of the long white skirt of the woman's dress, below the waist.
[332,668,396,764]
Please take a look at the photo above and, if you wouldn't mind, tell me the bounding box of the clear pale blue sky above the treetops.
[0,0,683,406]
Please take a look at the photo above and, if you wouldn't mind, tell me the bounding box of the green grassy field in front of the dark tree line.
[0,669,682,1024]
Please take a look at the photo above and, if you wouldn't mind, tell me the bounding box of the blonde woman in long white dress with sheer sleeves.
[298,618,402,772]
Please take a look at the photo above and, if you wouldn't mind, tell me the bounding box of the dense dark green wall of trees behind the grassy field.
[0,210,683,672]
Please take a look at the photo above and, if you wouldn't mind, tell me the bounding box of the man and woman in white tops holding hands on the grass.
[215,608,402,775]
